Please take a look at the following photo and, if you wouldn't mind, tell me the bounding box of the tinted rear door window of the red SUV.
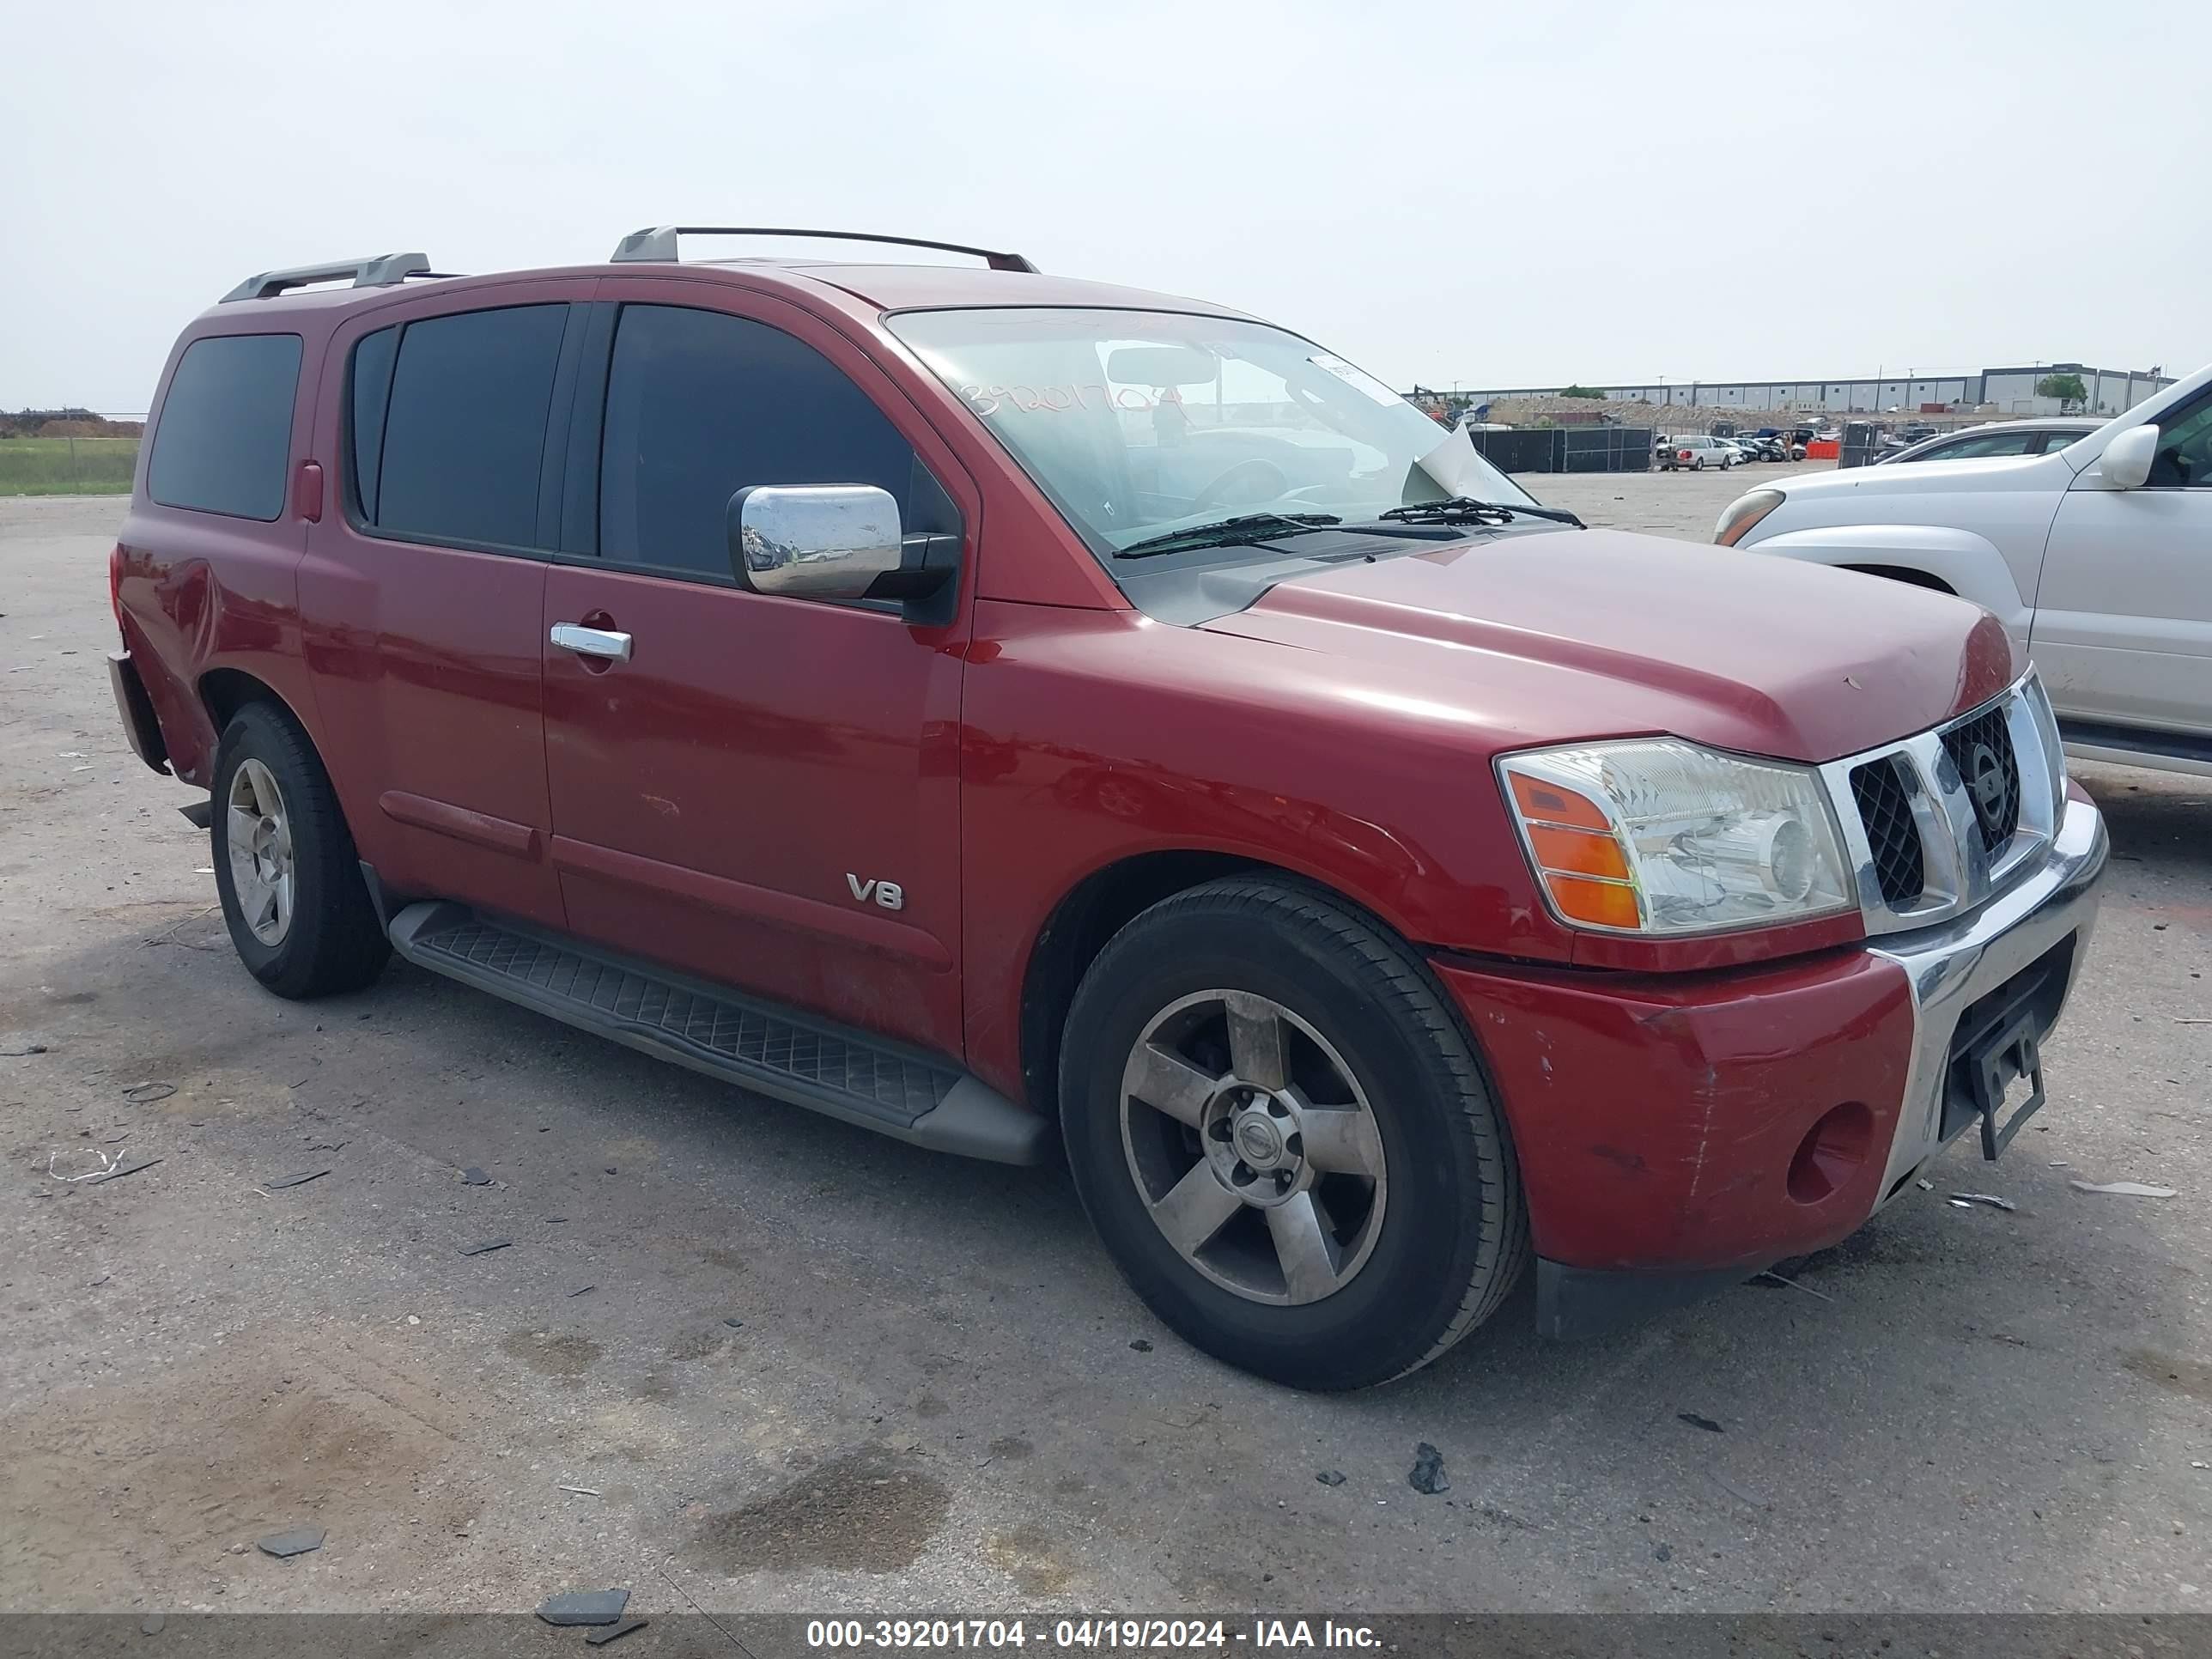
[371,305,568,546]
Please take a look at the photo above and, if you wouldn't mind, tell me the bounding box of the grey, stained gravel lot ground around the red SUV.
[0,493,2212,1613]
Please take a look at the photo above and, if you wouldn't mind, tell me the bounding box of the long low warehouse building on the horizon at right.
[1458,362,2174,416]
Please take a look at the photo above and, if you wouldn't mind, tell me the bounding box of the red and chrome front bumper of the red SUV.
[1436,785,2108,1336]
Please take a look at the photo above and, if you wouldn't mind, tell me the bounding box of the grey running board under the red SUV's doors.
[389,900,1051,1164]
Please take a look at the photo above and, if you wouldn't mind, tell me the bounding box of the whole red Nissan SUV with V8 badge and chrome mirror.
[112,226,2106,1389]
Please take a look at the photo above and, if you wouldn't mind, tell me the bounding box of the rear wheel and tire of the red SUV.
[210,703,392,1000]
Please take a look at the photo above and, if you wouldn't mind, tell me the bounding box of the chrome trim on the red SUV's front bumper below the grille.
[1869,794,2111,1210]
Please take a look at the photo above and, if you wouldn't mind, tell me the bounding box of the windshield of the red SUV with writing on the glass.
[887,307,1533,557]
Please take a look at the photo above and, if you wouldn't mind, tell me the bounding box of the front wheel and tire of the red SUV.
[1060,878,1528,1389]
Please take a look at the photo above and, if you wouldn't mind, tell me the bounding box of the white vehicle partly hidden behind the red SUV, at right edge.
[1714,369,2212,776]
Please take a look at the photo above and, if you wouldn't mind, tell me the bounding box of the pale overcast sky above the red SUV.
[0,0,2212,411]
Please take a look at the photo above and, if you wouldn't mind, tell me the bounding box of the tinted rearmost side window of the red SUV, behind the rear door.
[146,334,299,522]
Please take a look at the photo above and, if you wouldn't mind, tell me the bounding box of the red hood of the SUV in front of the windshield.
[1206,531,2020,761]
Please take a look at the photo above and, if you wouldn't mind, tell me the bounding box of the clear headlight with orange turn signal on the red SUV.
[1498,737,1856,936]
